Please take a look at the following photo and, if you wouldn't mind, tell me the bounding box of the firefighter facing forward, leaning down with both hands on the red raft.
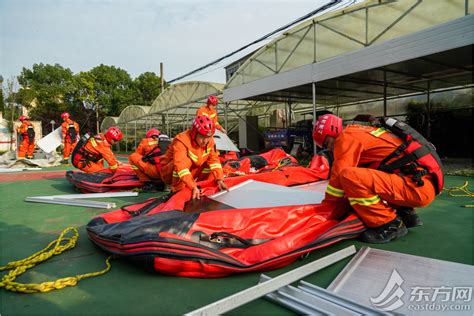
[161,116,227,199]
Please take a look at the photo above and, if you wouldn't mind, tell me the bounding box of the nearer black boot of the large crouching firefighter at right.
[359,217,408,244]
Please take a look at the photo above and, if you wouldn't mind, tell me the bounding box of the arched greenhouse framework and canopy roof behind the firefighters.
[102,0,474,152]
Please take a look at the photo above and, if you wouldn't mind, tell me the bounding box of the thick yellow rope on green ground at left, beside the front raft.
[0,227,112,293]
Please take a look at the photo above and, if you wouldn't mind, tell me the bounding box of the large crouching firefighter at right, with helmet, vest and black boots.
[313,114,443,243]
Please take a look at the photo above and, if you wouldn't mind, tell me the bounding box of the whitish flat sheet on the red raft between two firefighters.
[209,180,326,208]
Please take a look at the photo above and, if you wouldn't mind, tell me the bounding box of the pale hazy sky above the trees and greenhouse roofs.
[0,0,348,83]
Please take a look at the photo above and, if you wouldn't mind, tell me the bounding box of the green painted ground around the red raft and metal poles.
[0,173,474,316]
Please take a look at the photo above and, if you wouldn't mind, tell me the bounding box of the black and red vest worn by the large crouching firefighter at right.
[371,118,444,194]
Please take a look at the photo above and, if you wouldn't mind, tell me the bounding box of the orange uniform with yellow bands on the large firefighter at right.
[323,125,436,227]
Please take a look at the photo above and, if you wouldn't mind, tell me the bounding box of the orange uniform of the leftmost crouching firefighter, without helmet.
[79,133,118,173]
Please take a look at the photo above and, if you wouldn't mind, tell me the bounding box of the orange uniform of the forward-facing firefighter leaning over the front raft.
[161,130,224,192]
